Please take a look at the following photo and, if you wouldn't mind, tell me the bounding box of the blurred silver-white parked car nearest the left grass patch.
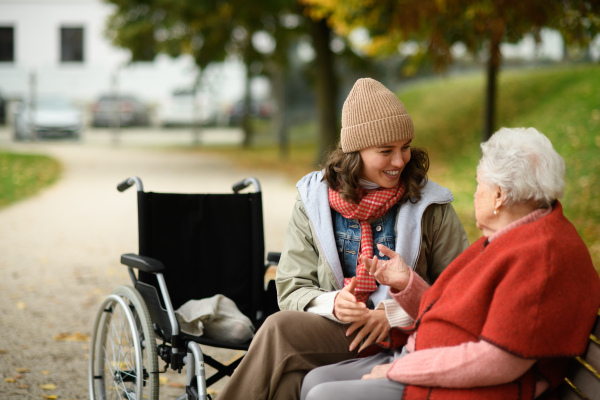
[14,96,83,140]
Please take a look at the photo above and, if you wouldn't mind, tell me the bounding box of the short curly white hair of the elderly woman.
[477,128,565,207]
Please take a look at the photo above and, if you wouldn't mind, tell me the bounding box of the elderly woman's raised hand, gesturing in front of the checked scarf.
[362,244,410,290]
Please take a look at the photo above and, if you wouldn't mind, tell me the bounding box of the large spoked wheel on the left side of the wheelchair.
[89,286,158,400]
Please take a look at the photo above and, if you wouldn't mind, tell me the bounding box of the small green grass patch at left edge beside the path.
[0,151,62,208]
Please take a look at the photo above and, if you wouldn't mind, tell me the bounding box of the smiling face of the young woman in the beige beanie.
[359,139,412,189]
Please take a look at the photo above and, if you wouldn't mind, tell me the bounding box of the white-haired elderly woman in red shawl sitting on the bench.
[301,128,600,400]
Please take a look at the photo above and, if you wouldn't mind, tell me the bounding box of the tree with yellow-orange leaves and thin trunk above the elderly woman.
[300,0,600,140]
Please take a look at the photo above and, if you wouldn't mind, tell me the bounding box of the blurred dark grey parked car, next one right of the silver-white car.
[92,95,150,126]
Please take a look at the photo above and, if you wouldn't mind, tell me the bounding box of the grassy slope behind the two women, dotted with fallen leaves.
[202,65,600,270]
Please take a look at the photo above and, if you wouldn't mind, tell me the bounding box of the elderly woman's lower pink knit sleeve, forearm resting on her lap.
[387,341,536,388]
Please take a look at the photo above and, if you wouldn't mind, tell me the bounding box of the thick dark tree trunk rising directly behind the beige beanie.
[309,20,339,163]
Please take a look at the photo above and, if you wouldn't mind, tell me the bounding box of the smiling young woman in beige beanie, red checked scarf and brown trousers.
[219,78,468,400]
